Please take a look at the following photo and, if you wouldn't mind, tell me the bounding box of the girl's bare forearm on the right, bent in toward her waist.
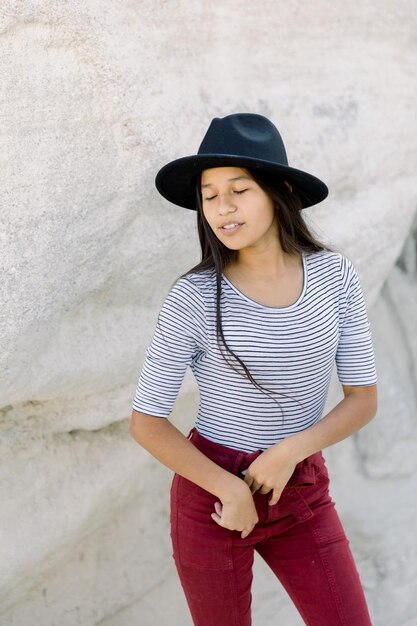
[273,387,377,463]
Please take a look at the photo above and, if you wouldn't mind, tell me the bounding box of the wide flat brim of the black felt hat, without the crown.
[155,154,329,210]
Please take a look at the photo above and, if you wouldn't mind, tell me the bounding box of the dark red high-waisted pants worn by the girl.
[171,429,371,626]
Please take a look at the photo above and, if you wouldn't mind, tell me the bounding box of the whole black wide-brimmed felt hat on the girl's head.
[155,113,329,210]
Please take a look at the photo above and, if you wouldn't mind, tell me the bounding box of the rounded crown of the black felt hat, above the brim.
[198,113,288,165]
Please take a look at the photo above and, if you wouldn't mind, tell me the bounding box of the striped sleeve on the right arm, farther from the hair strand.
[336,255,377,385]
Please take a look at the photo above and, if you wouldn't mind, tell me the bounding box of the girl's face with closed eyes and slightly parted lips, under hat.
[201,167,279,250]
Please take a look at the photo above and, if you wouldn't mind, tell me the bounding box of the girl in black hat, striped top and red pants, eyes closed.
[131,113,377,626]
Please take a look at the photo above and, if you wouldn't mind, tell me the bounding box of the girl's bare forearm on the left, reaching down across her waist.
[130,411,246,502]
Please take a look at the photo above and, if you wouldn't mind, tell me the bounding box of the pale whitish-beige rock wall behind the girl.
[0,0,417,626]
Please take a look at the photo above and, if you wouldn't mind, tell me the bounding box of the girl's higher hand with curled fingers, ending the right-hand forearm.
[243,444,297,506]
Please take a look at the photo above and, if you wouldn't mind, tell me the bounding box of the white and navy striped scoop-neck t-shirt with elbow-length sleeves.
[133,251,377,452]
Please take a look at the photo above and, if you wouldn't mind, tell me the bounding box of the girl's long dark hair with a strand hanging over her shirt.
[181,169,333,410]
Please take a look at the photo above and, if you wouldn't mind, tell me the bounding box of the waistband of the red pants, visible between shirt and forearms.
[187,428,324,476]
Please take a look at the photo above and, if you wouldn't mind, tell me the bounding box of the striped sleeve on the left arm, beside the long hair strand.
[132,277,205,417]
